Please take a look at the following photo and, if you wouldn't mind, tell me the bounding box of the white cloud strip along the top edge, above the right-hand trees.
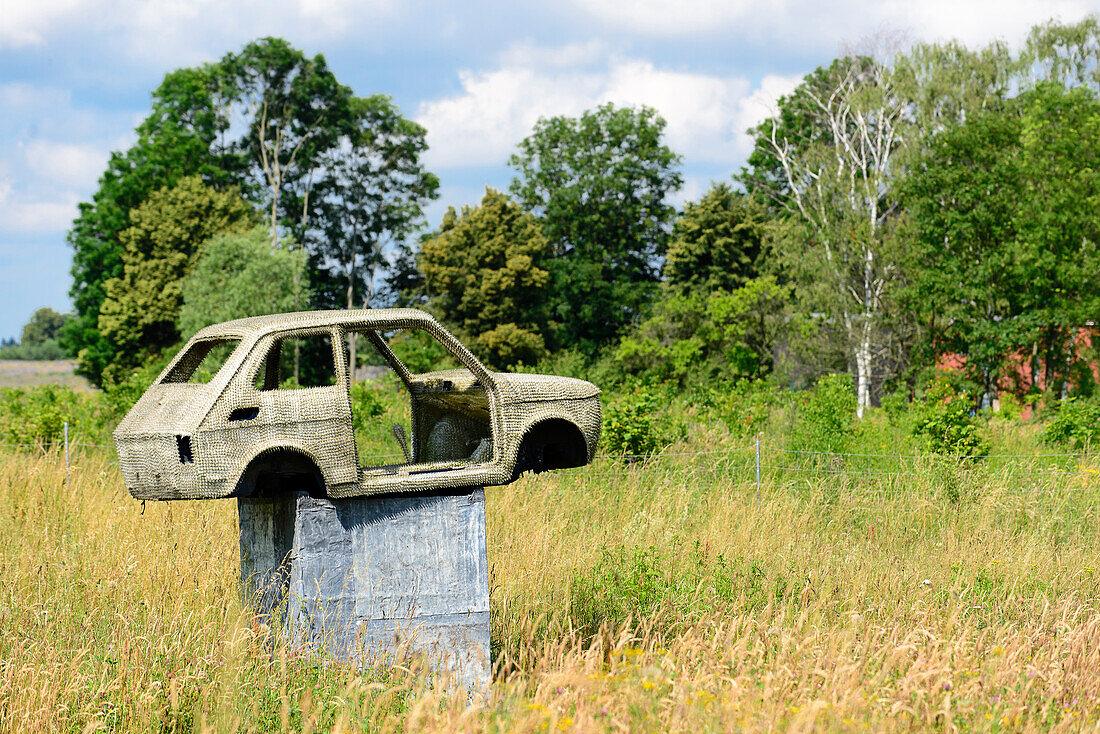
[567,0,1100,48]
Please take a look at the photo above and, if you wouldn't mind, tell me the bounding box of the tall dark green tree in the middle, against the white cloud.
[509,103,682,351]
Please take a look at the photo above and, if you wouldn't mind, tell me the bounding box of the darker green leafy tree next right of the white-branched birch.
[903,101,1024,402]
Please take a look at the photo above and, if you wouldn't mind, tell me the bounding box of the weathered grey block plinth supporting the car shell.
[238,489,490,691]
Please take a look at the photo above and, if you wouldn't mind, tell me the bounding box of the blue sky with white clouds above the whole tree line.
[0,0,1100,338]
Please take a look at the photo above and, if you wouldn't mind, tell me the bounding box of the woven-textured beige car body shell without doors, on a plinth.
[114,308,601,500]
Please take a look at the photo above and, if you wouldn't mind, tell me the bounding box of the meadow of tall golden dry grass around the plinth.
[0,385,1100,732]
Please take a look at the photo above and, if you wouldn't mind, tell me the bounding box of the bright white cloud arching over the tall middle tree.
[417,46,799,167]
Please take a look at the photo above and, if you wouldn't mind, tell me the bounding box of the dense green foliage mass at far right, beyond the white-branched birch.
[908,83,1100,392]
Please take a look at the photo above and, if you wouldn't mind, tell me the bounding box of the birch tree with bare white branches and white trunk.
[755,48,910,416]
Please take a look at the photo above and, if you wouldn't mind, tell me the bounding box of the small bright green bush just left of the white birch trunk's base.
[791,374,857,453]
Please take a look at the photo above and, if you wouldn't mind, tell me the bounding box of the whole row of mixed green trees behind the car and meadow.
[61,17,1100,412]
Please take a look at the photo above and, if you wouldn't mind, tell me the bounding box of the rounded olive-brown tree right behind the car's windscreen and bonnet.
[418,188,551,368]
